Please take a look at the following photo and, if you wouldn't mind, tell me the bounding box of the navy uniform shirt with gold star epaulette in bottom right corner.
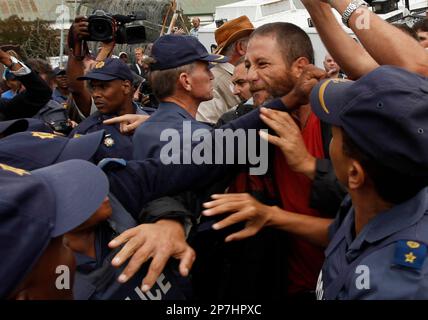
[316,188,428,300]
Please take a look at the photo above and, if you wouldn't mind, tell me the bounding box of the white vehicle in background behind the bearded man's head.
[199,0,428,67]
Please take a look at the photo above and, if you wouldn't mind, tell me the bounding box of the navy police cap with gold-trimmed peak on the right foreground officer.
[310,66,428,176]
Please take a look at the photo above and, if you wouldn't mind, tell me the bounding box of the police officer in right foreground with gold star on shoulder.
[311,66,428,299]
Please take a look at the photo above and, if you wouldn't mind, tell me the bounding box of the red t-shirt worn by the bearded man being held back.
[274,112,324,294]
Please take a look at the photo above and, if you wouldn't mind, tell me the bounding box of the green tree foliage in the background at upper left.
[0,16,60,59]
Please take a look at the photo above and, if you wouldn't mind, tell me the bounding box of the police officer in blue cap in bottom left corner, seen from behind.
[0,160,108,300]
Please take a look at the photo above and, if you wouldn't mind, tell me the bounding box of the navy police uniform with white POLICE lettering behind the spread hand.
[73,195,192,300]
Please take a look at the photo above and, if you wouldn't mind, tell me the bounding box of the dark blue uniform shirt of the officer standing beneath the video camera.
[70,104,147,163]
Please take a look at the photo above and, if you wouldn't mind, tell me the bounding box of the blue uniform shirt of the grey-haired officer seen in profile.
[133,102,211,160]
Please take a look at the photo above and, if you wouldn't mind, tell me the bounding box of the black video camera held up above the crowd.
[85,10,146,44]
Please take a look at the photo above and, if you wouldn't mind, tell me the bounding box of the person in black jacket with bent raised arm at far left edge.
[0,49,52,120]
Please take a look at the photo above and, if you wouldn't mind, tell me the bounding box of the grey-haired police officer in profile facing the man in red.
[134,35,228,159]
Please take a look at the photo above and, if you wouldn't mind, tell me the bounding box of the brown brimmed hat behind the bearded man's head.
[215,16,254,54]
